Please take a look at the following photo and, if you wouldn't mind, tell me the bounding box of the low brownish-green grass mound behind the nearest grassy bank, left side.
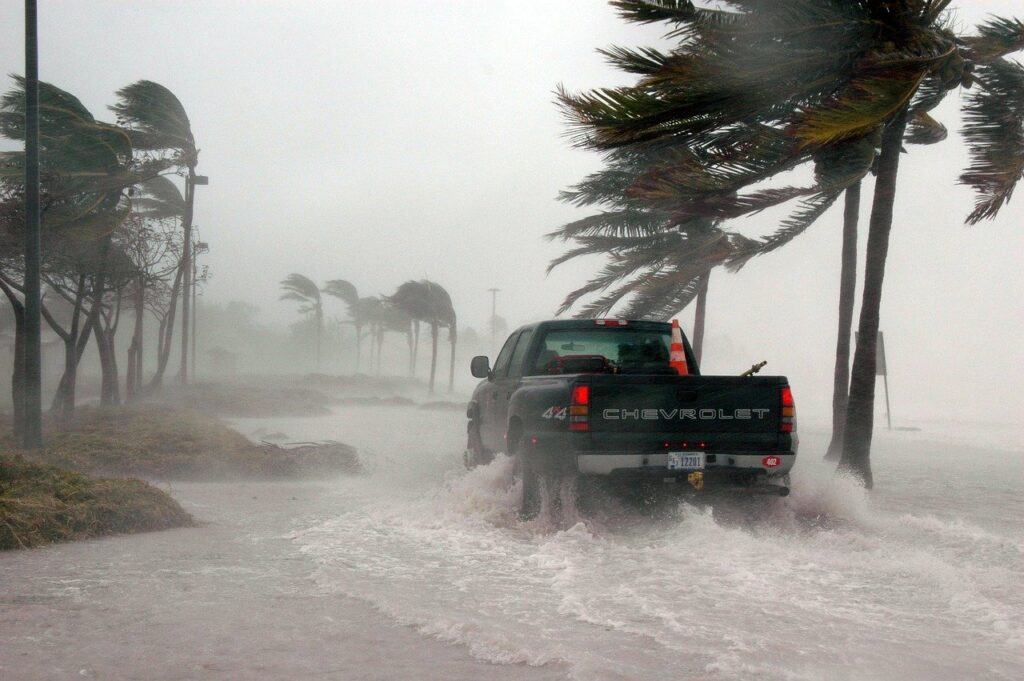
[0,406,360,479]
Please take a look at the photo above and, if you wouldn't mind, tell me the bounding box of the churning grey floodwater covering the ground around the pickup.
[0,407,1024,681]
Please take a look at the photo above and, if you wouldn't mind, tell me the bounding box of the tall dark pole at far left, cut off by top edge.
[22,0,43,450]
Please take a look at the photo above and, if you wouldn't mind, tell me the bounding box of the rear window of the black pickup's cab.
[529,328,676,376]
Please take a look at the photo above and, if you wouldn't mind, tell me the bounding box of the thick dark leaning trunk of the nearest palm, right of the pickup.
[840,110,907,490]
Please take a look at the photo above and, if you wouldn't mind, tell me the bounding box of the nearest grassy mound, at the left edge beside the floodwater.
[0,454,195,549]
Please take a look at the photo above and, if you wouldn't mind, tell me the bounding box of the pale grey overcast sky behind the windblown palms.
[0,0,1024,423]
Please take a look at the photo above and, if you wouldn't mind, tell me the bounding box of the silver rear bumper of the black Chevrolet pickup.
[577,452,797,477]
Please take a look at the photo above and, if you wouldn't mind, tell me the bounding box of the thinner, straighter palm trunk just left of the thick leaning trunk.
[825,181,860,461]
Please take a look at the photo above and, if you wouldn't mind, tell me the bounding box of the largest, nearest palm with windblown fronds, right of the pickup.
[560,0,1024,486]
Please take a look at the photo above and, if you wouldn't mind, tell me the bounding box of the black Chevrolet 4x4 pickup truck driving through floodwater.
[466,320,798,515]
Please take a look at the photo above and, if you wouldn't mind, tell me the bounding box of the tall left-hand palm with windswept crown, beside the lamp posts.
[111,80,199,383]
